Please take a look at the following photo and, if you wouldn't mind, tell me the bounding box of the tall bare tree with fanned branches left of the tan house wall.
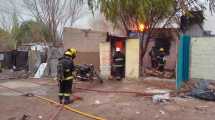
[23,0,84,41]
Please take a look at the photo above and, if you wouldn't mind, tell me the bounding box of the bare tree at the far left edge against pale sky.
[0,0,23,49]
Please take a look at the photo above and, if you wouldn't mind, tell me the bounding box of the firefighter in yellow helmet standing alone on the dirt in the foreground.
[57,48,77,104]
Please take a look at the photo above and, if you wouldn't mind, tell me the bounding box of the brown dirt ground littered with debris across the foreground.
[0,79,215,120]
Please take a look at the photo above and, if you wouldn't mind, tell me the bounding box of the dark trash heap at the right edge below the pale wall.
[188,80,215,101]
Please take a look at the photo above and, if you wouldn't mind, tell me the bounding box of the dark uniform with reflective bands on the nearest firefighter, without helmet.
[58,55,74,104]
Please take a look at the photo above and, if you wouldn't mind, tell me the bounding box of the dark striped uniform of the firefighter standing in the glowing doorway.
[113,51,125,80]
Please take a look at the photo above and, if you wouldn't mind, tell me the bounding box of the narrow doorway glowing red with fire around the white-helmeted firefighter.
[109,36,126,77]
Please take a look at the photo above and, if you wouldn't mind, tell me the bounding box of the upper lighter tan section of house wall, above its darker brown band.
[63,28,107,52]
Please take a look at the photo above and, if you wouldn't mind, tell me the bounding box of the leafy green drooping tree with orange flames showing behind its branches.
[88,0,177,62]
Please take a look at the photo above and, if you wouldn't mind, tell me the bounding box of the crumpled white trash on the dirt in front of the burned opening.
[152,93,170,103]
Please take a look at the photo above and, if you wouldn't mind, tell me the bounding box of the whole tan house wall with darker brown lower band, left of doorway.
[63,28,107,70]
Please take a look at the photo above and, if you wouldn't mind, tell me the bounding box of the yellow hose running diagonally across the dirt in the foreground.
[35,95,105,120]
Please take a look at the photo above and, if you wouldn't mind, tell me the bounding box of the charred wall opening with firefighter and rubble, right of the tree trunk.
[142,29,178,79]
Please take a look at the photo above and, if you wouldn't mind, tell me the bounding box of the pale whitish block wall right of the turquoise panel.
[190,37,215,80]
